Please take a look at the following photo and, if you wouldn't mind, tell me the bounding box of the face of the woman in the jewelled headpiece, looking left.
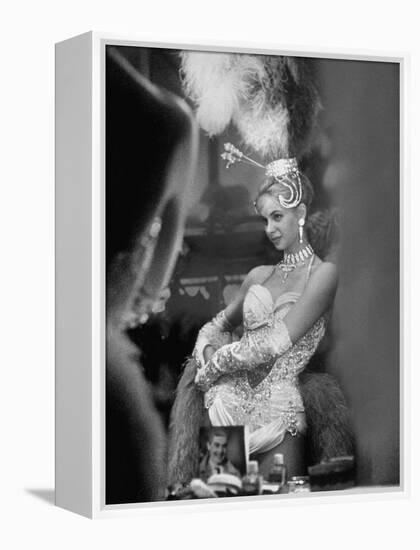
[257,194,301,252]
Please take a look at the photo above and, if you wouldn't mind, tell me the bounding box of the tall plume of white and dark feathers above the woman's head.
[181,52,321,159]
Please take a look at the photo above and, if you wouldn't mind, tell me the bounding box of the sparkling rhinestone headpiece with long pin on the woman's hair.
[221,143,302,208]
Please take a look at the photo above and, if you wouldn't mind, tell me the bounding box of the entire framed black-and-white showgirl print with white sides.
[56,33,406,517]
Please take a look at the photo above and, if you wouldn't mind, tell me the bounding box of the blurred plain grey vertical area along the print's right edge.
[320,60,400,485]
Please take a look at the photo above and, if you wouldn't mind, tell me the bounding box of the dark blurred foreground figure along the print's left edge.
[106,48,198,504]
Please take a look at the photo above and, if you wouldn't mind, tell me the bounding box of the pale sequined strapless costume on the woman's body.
[197,262,326,454]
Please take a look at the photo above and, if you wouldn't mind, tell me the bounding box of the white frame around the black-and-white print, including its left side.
[56,32,409,518]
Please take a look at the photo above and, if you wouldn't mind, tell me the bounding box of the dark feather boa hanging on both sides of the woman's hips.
[168,358,354,485]
